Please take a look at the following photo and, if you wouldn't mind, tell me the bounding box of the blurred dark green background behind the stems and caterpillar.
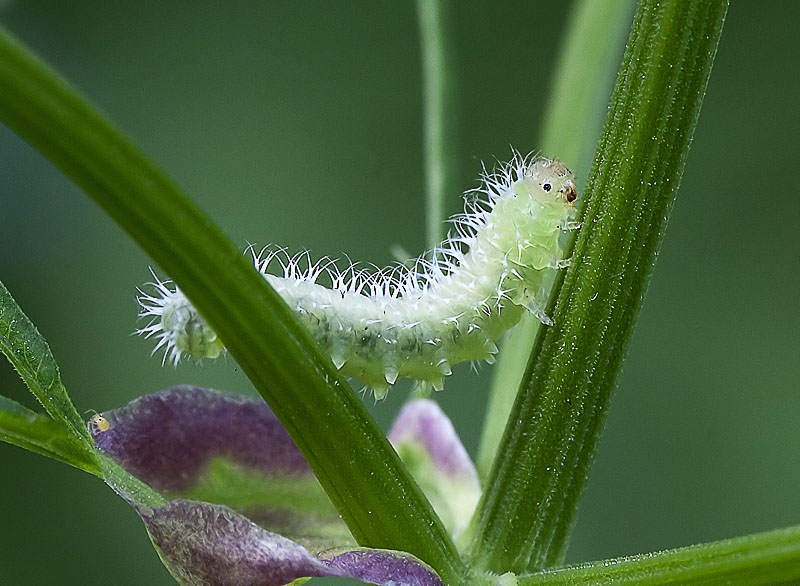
[0,0,800,586]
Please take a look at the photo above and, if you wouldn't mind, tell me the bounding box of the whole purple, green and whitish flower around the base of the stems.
[89,387,480,586]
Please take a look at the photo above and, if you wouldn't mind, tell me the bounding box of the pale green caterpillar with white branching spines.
[137,153,579,399]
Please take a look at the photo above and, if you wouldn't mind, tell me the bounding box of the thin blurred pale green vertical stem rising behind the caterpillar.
[417,0,458,248]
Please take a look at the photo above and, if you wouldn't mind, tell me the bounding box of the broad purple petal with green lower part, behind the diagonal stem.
[89,387,354,551]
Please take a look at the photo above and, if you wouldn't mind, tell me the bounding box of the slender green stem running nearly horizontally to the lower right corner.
[519,527,800,586]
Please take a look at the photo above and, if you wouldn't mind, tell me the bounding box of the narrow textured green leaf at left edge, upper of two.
[0,276,92,446]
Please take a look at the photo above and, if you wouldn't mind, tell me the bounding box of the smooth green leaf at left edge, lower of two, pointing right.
[0,396,101,476]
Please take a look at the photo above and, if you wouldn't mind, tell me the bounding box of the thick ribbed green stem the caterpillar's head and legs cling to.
[470,0,727,573]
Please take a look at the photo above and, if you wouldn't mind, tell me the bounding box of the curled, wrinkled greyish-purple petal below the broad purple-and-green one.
[140,500,346,586]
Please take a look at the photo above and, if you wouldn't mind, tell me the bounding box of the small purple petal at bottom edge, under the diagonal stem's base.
[323,549,444,586]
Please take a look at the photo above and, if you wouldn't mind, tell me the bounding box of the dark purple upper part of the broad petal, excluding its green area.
[89,387,311,492]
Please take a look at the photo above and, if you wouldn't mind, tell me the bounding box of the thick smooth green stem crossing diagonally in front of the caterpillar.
[0,30,463,583]
